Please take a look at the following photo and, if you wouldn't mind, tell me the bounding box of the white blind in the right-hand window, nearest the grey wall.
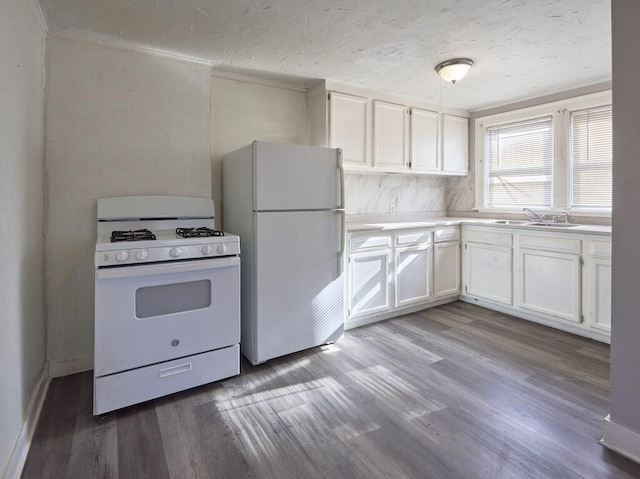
[570,106,613,209]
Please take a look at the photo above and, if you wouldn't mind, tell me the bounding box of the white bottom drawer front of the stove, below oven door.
[93,345,240,415]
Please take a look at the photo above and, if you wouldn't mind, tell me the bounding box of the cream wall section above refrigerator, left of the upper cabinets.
[211,74,310,227]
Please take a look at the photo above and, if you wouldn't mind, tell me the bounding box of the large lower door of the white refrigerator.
[254,211,345,364]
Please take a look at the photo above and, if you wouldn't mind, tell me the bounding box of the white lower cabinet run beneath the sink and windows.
[461,226,611,342]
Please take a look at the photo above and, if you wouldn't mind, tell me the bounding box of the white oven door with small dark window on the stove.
[95,256,240,376]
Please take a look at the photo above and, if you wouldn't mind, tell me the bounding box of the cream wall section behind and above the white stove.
[46,37,211,377]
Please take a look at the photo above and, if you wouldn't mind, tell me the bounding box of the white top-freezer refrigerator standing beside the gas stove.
[222,141,345,364]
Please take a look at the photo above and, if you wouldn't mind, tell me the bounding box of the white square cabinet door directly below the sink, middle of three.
[518,249,581,323]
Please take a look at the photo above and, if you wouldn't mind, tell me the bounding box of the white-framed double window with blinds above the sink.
[474,91,612,215]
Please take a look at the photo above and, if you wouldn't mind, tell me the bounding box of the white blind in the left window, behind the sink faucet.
[485,116,553,207]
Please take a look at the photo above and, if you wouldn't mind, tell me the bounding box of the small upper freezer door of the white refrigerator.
[253,141,342,211]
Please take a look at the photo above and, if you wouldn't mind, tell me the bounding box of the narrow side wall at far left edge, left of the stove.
[0,0,45,476]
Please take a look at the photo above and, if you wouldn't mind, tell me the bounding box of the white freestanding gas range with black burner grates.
[94,196,240,414]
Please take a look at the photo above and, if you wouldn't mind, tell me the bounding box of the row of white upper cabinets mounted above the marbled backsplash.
[308,80,469,175]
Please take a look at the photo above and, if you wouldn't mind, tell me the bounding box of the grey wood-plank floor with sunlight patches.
[22,302,640,479]
